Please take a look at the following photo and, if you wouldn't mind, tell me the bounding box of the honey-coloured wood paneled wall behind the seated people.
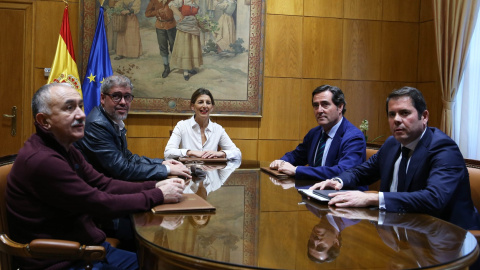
[23,0,442,160]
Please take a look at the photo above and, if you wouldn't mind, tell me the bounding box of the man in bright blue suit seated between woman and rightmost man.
[270,85,366,185]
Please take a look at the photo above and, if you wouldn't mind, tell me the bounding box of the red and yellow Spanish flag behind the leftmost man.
[48,5,82,95]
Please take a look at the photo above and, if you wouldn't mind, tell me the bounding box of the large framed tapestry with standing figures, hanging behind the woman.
[81,0,265,117]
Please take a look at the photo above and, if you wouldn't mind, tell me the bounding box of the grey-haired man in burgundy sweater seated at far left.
[6,84,185,269]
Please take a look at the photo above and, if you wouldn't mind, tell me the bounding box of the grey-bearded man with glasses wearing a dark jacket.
[75,75,191,250]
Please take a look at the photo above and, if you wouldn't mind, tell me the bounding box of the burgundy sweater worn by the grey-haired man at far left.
[6,125,163,269]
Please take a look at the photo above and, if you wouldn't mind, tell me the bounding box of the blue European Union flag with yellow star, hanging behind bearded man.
[82,7,113,115]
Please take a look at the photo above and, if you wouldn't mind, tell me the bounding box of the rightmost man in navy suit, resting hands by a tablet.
[311,87,480,229]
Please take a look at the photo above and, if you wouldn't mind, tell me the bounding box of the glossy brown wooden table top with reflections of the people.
[133,161,479,269]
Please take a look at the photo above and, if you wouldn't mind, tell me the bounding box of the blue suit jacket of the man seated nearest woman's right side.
[281,117,366,181]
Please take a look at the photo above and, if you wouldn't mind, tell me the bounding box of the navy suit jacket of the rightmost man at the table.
[339,127,480,229]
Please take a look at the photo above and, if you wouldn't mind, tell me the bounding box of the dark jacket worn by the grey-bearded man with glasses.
[74,106,168,181]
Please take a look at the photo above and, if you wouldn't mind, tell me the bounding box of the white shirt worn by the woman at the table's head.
[164,116,242,160]
